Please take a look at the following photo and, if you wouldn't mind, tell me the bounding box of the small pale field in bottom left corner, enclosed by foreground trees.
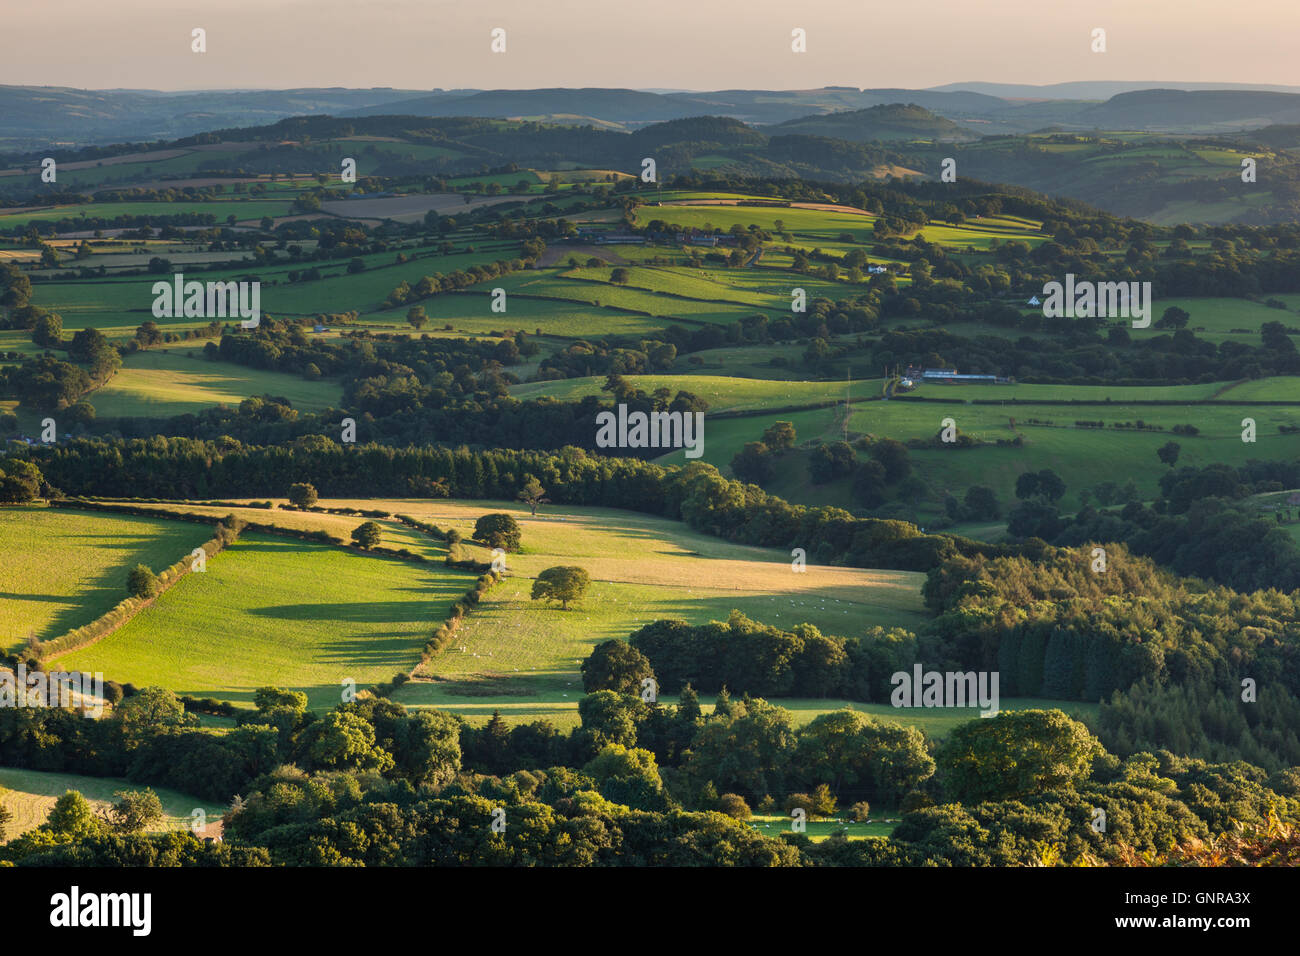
[0,767,228,840]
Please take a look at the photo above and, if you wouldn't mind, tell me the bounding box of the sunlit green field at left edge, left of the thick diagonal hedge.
[0,506,212,650]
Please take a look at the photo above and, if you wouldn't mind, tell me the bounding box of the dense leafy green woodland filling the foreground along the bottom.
[0,688,1300,866]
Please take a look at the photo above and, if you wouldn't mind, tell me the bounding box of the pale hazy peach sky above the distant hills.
[0,0,1300,90]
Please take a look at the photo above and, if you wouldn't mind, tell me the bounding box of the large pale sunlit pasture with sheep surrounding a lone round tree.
[356,502,923,714]
